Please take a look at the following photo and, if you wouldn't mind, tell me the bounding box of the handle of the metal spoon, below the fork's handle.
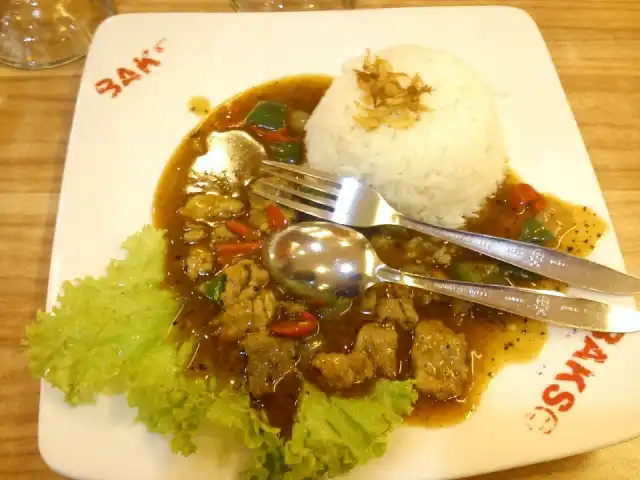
[376,265,640,333]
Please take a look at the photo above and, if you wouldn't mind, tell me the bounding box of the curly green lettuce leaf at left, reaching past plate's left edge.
[26,227,283,468]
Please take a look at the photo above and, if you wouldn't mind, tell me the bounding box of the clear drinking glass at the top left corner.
[0,0,115,69]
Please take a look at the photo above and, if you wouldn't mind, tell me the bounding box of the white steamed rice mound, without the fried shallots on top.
[306,45,506,227]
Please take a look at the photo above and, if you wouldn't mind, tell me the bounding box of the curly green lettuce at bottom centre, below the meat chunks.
[284,380,417,480]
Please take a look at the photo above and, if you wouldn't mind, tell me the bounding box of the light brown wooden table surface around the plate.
[0,0,640,480]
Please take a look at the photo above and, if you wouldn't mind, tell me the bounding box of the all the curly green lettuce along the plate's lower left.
[26,227,416,480]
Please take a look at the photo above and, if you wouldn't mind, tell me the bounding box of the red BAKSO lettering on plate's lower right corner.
[526,332,624,435]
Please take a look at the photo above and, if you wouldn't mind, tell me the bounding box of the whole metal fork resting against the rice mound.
[253,160,640,295]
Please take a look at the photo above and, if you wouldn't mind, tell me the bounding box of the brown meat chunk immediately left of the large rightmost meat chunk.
[355,323,398,378]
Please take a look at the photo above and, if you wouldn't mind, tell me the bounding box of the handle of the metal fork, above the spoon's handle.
[394,214,640,295]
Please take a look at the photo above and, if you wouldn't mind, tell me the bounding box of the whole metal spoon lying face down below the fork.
[264,222,640,333]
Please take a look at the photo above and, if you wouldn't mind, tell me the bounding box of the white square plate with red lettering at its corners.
[39,7,640,480]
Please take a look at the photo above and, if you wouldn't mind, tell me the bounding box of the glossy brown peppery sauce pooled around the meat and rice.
[153,76,606,436]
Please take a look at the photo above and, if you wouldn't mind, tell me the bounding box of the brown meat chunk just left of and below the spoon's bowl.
[220,260,269,308]
